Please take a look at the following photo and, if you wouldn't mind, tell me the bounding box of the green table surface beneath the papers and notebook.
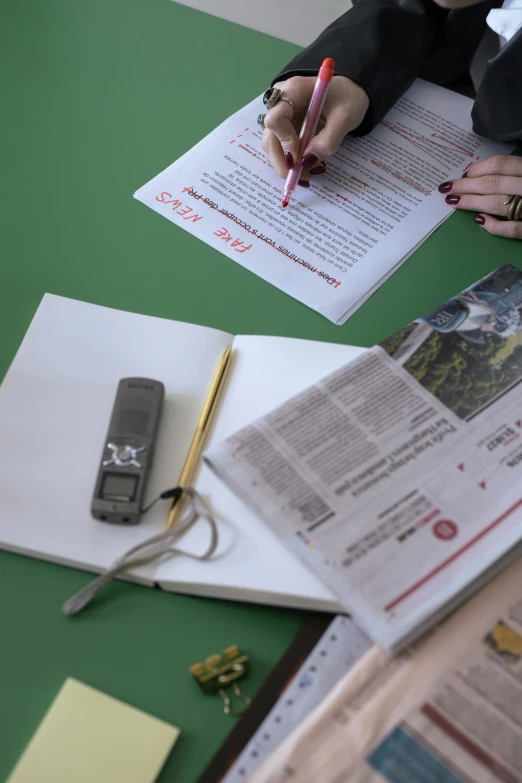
[0,0,521,783]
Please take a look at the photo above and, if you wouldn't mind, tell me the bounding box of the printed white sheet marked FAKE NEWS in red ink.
[135,80,512,324]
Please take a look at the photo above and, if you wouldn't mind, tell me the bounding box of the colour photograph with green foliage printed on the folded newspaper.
[381,264,522,420]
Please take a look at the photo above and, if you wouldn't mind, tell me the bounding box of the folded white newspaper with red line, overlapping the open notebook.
[205,265,522,650]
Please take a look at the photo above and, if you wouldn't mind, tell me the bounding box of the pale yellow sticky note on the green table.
[7,679,179,783]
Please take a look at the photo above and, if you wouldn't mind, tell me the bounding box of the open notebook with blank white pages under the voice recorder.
[0,294,362,611]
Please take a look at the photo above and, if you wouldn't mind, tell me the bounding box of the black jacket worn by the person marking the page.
[274,0,522,141]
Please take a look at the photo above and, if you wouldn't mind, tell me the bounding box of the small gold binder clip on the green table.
[189,644,252,715]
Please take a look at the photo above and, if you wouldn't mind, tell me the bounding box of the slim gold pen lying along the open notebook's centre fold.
[167,345,232,530]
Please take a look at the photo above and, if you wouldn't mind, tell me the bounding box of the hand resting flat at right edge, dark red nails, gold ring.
[439,155,522,239]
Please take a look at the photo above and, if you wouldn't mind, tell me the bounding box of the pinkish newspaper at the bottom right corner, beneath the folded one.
[249,563,522,783]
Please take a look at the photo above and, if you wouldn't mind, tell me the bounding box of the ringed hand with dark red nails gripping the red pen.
[263,76,369,186]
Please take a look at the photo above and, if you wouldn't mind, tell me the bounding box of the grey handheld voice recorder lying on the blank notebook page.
[91,378,165,525]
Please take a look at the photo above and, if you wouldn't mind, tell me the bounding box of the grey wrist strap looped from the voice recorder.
[62,487,219,617]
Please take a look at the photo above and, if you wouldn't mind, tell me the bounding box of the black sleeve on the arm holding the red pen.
[274,0,448,135]
